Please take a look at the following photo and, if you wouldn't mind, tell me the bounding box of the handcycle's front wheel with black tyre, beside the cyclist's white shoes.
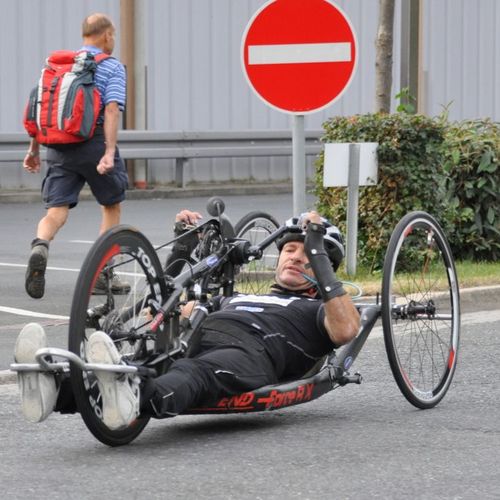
[68,226,166,446]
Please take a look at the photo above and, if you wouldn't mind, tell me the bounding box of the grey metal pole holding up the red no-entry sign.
[292,115,306,216]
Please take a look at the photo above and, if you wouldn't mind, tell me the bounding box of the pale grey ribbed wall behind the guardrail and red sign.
[0,0,500,188]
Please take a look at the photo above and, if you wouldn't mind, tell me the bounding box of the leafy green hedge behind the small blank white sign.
[315,113,500,271]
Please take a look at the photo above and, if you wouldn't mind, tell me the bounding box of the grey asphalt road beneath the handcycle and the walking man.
[0,195,500,500]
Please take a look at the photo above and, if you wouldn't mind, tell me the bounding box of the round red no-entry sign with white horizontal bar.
[241,0,357,114]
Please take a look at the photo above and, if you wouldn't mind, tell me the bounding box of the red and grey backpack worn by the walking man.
[24,50,110,145]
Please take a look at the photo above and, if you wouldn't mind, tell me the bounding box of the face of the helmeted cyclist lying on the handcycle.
[276,241,314,290]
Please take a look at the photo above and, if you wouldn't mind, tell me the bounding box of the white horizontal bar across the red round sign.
[248,42,351,64]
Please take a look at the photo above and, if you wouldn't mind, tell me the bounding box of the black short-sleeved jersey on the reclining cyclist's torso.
[203,293,334,379]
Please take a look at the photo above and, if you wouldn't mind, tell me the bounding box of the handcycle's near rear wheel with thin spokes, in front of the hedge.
[382,212,460,409]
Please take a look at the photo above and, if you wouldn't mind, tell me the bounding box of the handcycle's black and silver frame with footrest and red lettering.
[11,219,380,413]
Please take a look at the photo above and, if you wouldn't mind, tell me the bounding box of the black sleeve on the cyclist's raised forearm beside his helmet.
[304,222,346,302]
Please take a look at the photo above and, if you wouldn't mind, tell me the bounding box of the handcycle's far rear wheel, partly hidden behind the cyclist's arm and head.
[234,210,280,294]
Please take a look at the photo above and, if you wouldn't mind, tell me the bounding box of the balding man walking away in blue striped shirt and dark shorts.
[23,13,128,299]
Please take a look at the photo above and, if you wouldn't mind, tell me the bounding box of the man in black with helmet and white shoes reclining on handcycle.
[15,210,360,430]
